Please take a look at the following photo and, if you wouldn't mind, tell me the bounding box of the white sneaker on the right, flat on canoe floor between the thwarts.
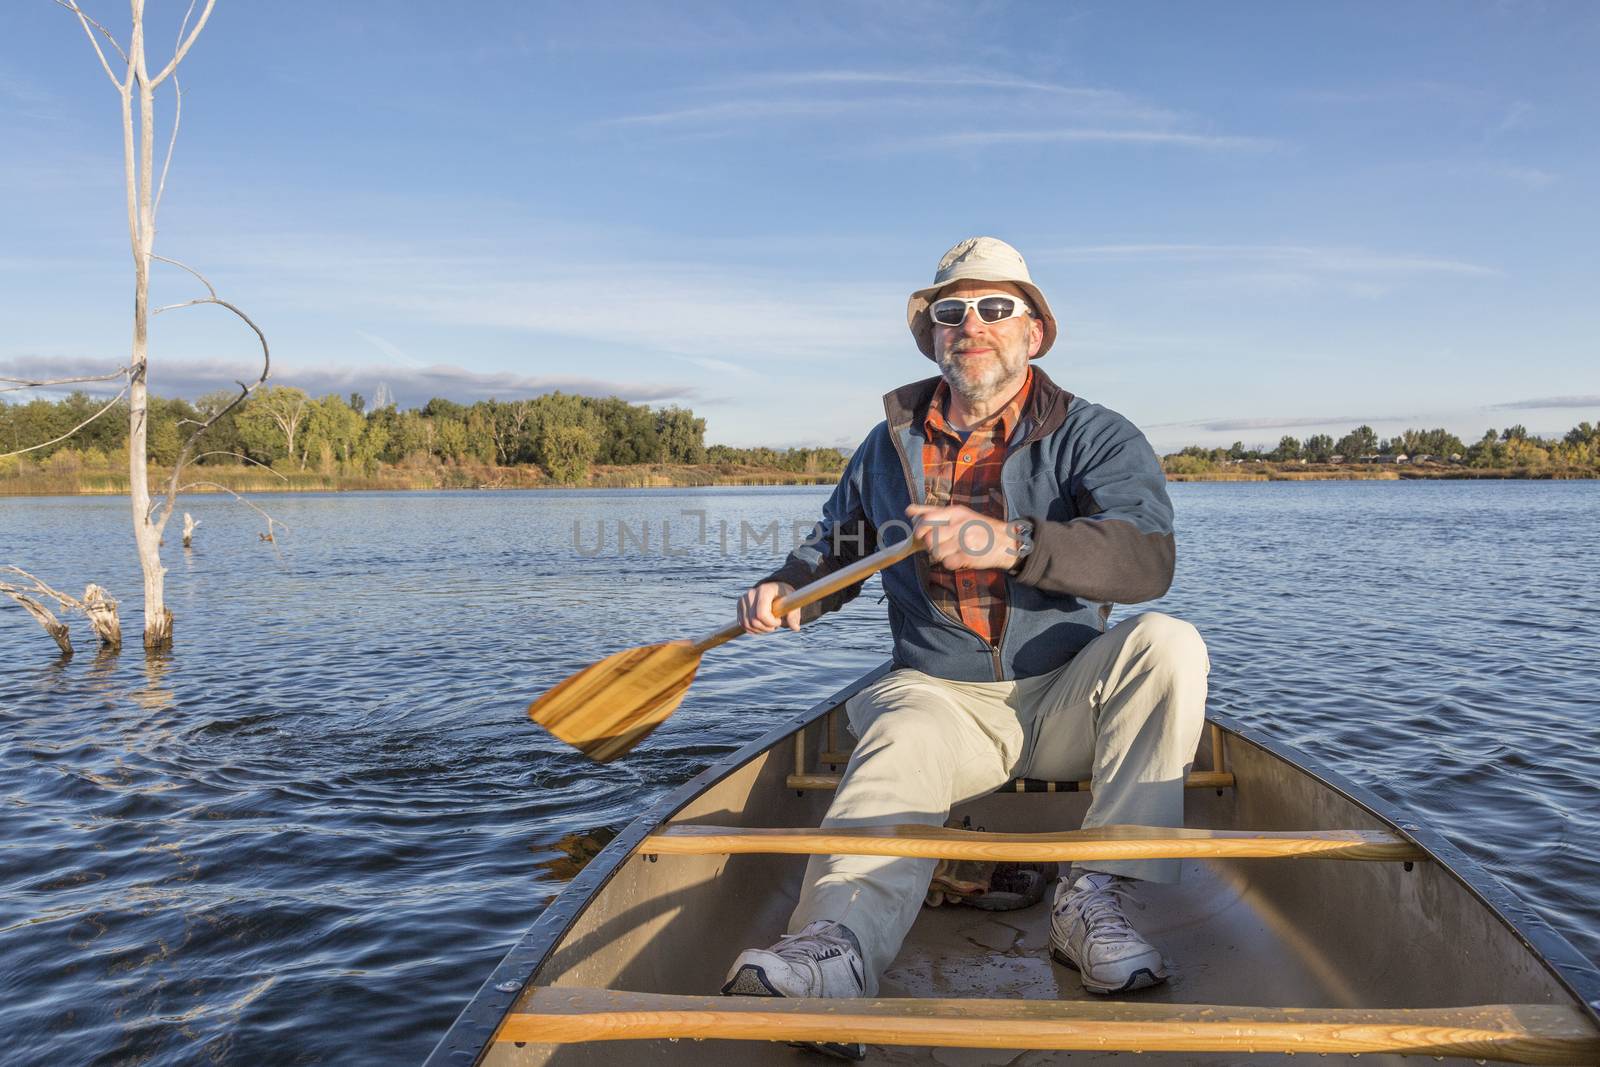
[1050,872,1166,995]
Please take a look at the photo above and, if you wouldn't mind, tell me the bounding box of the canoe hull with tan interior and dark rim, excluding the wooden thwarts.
[429,667,1600,1067]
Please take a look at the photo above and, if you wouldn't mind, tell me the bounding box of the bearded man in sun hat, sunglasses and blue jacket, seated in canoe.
[723,237,1210,1023]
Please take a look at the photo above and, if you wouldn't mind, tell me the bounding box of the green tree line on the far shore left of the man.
[0,386,843,485]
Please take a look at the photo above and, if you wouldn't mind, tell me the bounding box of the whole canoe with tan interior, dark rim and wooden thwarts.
[427,664,1600,1067]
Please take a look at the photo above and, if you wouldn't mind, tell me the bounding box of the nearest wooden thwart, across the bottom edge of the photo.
[494,987,1600,1064]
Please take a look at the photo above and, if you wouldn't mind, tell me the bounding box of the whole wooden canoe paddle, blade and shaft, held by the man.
[528,537,923,763]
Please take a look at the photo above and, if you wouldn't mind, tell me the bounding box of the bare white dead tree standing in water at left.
[39,0,272,651]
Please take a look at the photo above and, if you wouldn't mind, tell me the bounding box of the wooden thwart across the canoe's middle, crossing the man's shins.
[638,824,1427,862]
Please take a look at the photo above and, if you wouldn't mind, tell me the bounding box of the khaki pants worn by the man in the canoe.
[789,613,1211,990]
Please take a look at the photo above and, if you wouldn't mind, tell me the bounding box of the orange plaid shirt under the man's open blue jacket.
[922,366,1034,645]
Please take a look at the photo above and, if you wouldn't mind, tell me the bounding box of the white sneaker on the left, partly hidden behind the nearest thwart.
[722,920,877,1059]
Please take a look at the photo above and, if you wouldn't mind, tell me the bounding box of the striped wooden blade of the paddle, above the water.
[528,641,701,763]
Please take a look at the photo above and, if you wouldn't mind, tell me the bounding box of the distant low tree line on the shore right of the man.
[1165,422,1600,474]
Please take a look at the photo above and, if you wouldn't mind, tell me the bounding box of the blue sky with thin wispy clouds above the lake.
[0,0,1600,448]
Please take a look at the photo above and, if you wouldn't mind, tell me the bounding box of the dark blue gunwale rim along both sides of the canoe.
[424,662,1600,1067]
